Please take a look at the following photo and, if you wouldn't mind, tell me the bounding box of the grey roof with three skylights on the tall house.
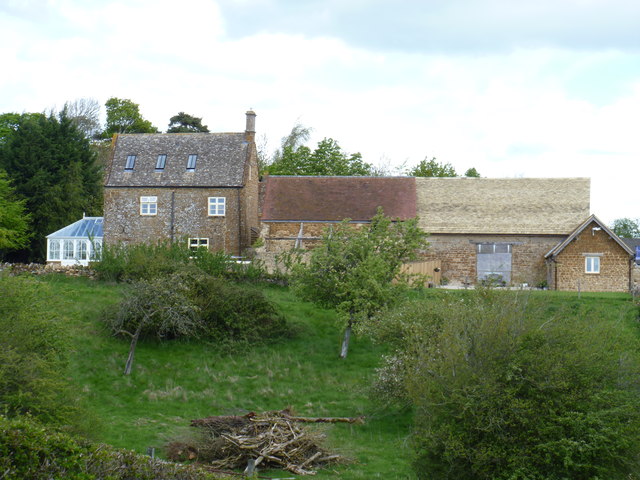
[105,132,249,187]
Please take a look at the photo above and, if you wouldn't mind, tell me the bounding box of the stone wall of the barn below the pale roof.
[421,234,563,286]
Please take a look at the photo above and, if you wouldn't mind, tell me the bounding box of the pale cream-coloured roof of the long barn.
[416,177,590,235]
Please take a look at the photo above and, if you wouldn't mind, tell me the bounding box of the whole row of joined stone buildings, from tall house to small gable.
[97,111,634,291]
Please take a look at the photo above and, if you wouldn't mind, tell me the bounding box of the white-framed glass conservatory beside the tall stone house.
[47,216,102,266]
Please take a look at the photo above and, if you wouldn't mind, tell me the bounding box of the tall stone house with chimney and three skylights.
[104,111,259,255]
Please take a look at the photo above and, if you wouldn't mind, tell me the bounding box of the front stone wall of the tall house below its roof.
[104,187,248,255]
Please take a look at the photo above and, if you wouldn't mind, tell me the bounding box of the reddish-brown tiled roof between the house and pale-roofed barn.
[262,175,416,222]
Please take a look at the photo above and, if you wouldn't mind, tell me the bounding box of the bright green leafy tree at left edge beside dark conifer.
[0,170,30,254]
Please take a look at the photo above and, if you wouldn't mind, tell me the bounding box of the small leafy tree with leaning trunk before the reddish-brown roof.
[292,209,427,358]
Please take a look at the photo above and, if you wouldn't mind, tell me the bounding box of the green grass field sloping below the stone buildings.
[37,275,638,480]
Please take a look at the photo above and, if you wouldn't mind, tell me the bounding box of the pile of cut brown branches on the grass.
[168,410,364,475]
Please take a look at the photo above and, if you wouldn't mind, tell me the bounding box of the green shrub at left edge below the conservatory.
[0,275,82,424]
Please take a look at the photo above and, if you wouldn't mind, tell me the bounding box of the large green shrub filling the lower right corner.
[364,290,640,480]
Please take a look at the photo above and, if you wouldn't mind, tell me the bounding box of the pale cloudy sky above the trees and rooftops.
[0,0,640,224]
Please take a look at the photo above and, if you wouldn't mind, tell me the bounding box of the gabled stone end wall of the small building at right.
[553,223,631,292]
